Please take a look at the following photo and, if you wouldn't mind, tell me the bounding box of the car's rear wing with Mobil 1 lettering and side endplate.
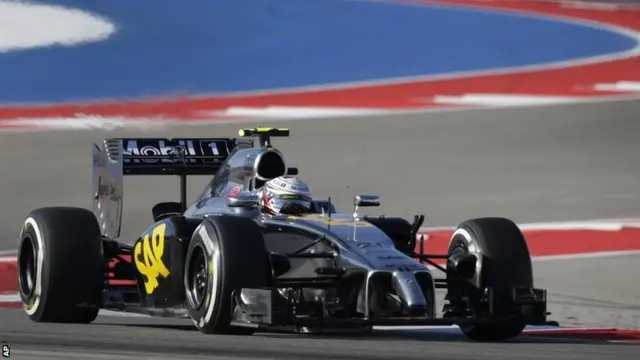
[93,138,245,239]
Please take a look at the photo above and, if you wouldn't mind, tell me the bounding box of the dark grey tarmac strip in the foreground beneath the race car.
[0,310,639,360]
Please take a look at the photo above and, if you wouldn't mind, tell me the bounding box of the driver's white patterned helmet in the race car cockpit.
[259,176,312,215]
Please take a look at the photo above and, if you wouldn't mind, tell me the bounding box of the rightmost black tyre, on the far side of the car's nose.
[448,218,533,341]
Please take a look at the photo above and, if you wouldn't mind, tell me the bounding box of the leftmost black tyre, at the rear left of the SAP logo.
[18,207,104,323]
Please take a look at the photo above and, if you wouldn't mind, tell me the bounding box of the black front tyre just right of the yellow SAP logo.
[184,216,273,335]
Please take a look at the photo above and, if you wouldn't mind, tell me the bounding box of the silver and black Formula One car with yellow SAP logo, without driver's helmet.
[13,128,557,341]
